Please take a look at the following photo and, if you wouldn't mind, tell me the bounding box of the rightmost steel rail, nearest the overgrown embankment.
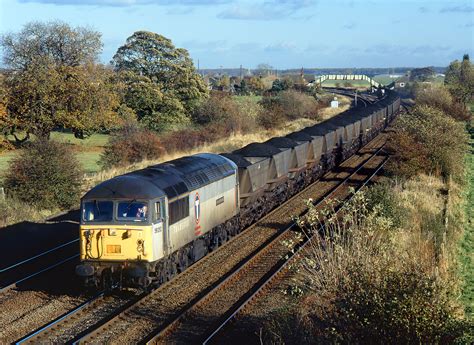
[202,155,390,345]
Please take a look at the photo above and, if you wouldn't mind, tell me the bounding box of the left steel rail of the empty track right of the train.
[144,144,385,345]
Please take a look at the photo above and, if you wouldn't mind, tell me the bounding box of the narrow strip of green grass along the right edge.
[460,127,474,320]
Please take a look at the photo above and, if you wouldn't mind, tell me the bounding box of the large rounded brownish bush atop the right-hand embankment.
[387,105,467,179]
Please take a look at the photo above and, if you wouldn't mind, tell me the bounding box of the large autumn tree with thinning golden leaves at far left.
[0,22,119,141]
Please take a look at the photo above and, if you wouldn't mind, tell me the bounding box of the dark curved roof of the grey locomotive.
[83,153,237,200]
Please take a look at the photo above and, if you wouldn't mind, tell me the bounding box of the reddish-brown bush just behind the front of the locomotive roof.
[100,126,165,168]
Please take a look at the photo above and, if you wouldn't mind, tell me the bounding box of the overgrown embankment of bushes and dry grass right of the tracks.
[225,99,474,344]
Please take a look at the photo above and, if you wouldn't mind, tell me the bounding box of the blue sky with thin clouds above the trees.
[0,0,474,69]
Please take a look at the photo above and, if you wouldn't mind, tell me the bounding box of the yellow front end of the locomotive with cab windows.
[76,199,164,288]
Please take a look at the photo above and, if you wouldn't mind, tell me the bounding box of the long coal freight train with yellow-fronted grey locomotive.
[76,91,400,288]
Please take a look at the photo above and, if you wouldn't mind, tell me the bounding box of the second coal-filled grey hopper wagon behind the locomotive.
[233,143,291,190]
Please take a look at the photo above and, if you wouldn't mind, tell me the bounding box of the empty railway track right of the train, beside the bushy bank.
[145,141,387,344]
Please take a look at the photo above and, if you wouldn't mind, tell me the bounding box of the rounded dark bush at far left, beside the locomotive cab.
[4,138,84,209]
